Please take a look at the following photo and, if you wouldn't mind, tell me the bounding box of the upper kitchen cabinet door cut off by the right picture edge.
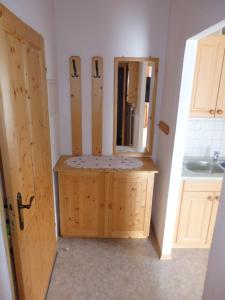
[216,47,225,118]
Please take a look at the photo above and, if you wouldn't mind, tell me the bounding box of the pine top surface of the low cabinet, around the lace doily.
[54,155,159,173]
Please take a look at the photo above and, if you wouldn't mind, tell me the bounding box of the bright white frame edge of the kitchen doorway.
[160,21,225,259]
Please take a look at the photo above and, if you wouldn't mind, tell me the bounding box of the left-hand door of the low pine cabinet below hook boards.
[59,171,105,237]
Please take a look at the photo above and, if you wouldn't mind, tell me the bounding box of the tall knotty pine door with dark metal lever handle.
[0,5,56,300]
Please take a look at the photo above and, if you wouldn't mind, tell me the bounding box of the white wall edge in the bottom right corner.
[203,175,225,300]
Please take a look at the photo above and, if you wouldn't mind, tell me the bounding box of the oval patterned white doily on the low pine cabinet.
[65,155,143,169]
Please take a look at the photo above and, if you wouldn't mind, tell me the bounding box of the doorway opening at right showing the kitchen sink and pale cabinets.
[163,21,225,300]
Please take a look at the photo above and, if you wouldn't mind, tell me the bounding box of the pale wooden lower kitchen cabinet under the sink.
[174,181,221,248]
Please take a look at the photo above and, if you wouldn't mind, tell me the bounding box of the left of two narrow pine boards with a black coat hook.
[70,56,82,155]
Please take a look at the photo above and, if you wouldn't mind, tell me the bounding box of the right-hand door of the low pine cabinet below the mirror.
[106,172,154,238]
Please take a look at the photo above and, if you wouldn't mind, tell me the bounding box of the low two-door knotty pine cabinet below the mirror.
[55,158,157,238]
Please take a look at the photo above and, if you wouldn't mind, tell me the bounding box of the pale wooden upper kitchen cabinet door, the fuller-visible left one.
[190,35,225,117]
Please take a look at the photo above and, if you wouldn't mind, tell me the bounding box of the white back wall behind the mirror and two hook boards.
[55,0,170,154]
